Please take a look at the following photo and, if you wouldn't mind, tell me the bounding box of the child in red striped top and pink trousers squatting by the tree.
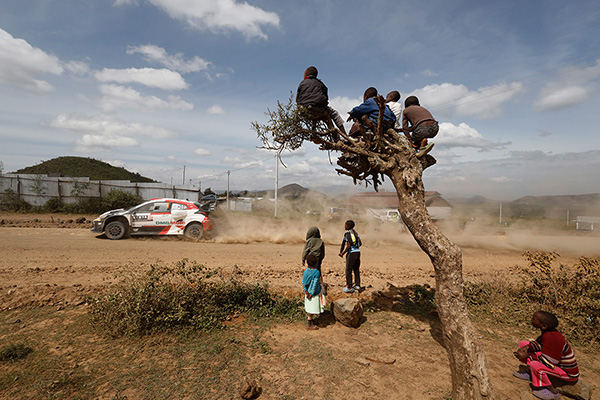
[513,310,579,399]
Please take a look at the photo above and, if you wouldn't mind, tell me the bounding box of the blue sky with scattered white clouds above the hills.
[0,0,600,200]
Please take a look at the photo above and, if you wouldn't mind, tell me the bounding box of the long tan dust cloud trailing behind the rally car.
[209,203,600,257]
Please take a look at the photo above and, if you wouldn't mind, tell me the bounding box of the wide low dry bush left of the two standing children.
[89,259,301,336]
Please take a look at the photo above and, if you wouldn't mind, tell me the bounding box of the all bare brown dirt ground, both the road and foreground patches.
[0,213,600,399]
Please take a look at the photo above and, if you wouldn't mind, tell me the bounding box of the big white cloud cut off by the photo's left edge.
[0,29,64,92]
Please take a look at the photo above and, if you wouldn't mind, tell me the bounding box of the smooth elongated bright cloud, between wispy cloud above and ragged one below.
[95,68,188,90]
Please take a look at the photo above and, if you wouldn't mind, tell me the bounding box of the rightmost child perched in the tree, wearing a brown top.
[402,96,440,157]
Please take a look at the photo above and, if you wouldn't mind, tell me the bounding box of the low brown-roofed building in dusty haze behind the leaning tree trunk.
[347,191,452,220]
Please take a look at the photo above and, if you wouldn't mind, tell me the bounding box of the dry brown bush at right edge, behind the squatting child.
[465,252,600,343]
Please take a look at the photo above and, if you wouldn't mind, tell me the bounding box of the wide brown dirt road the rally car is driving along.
[0,212,598,309]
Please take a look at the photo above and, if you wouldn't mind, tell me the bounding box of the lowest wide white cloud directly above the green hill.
[46,114,179,151]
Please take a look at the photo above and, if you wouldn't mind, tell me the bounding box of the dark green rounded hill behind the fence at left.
[12,157,156,182]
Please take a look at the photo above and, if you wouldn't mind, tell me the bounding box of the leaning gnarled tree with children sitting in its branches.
[252,96,495,400]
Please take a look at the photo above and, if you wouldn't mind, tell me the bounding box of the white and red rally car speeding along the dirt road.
[91,198,215,240]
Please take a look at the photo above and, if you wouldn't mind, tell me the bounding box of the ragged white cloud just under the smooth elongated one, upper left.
[93,85,194,112]
